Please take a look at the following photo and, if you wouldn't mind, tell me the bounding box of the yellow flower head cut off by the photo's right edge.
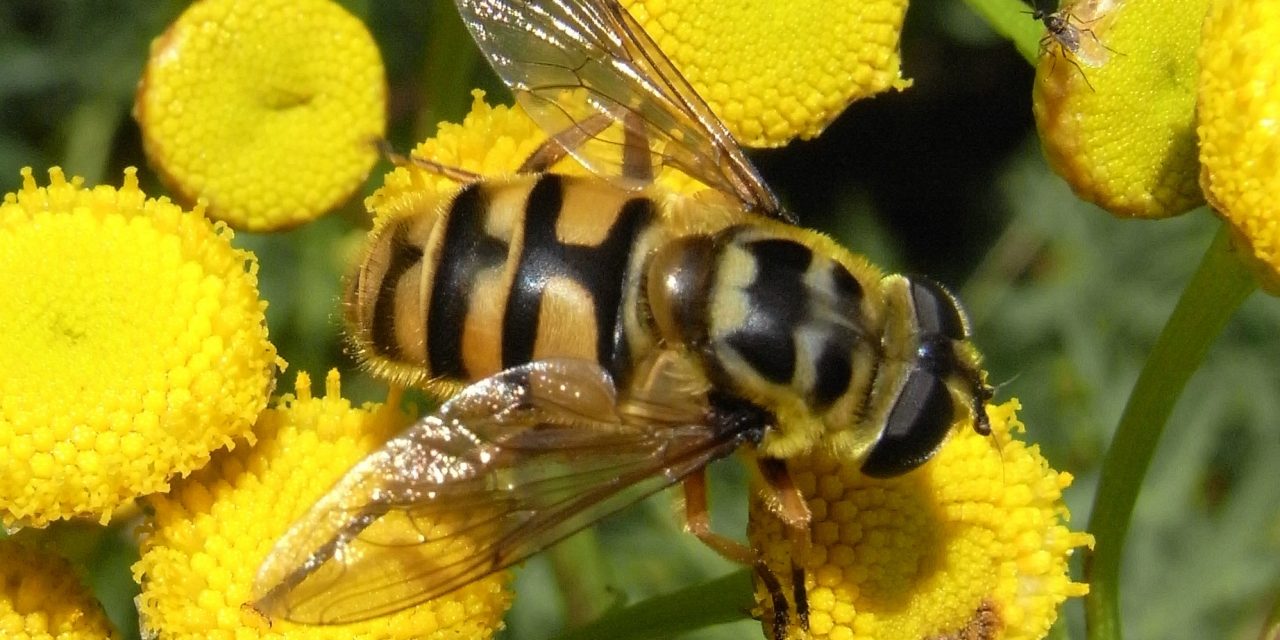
[1198,0,1280,294]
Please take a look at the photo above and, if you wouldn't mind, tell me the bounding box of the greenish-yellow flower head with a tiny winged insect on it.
[1033,0,1208,218]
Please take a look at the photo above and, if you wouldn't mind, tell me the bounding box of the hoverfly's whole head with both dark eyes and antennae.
[861,275,993,477]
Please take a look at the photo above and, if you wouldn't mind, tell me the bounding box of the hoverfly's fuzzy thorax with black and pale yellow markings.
[646,224,878,448]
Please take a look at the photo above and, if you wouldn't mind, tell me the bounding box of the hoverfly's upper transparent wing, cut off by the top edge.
[456,0,790,220]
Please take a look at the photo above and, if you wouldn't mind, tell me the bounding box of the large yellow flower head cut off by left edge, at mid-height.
[0,168,278,526]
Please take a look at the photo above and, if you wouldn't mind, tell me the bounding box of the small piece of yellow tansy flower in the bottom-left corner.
[0,539,119,640]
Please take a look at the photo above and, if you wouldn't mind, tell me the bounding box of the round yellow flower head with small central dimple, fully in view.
[134,0,387,230]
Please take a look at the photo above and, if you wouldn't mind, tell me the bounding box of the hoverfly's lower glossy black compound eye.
[863,367,955,477]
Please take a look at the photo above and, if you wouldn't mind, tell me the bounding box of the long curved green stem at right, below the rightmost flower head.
[1084,225,1257,640]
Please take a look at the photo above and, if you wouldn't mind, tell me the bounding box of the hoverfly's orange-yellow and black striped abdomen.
[347,174,655,384]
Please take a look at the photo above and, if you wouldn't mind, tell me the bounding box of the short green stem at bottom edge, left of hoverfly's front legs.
[559,570,755,640]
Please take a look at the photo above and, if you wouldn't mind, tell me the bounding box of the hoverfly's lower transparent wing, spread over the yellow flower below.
[253,360,744,623]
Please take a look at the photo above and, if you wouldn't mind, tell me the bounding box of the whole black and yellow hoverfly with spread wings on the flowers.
[253,0,992,628]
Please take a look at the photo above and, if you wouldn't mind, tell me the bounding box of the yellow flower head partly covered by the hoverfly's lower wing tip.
[133,371,511,639]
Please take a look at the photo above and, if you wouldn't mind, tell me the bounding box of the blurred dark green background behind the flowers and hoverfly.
[0,0,1280,640]
